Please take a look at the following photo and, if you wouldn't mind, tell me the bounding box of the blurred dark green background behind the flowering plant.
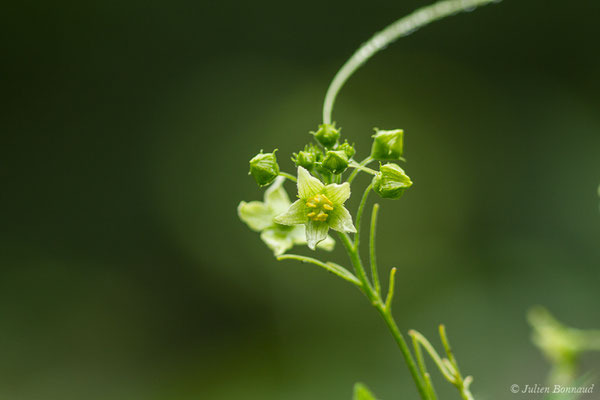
[0,0,600,400]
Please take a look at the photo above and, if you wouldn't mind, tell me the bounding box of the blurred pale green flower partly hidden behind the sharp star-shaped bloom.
[238,176,335,256]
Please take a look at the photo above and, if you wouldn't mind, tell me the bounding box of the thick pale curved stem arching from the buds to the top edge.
[323,0,497,124]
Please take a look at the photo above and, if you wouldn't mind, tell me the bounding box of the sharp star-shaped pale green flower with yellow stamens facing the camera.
[275,167,356,250]
